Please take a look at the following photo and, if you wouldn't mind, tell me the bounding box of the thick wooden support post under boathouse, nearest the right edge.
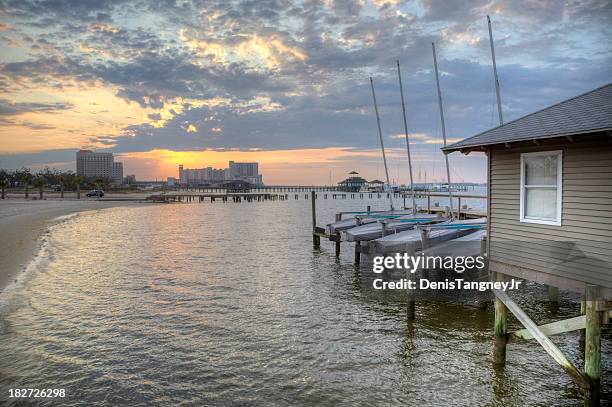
[584,285,602,407]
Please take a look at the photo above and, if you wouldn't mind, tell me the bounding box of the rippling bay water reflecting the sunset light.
[0,199,612,406]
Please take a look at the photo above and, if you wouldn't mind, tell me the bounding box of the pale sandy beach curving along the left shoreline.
[0,199,147,291]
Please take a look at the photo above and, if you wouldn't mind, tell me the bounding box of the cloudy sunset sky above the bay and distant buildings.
[0,0,612,185]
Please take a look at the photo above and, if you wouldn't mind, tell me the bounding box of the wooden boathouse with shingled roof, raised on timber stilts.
[443,84,612,404]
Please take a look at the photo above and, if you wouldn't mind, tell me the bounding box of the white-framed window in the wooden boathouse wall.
[521,151,563,226]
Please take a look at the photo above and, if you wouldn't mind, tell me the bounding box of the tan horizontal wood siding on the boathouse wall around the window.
[489,135,612,288]
